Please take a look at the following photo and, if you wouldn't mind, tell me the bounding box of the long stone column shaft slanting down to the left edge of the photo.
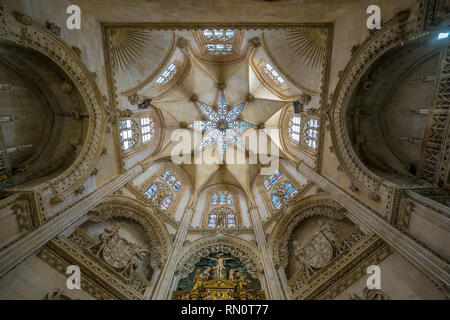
[0,164,144,277]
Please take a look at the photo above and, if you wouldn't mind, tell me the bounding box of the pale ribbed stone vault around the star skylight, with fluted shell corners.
[104,24,331,194]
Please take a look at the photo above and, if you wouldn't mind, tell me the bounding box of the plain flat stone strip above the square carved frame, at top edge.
[73,0,359,23]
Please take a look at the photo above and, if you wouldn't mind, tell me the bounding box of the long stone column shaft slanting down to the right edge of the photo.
[298,163,450,287]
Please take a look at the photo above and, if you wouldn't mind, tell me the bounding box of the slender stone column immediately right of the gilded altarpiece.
[250,207,285,300]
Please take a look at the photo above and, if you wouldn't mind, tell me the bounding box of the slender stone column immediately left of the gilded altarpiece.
[153,207,194,300]
